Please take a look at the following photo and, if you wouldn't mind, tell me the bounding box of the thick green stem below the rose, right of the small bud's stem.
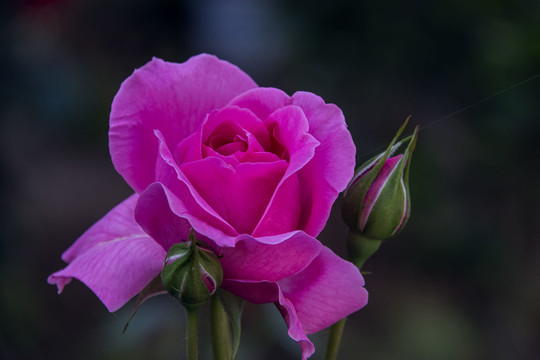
[210,295,232,360]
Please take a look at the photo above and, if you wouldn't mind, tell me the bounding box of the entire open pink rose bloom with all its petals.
[48,55,367,359]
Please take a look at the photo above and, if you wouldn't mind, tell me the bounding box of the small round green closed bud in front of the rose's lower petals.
[161,234,223,309]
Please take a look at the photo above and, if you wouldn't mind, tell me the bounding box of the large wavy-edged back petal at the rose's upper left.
[109,54,256,192]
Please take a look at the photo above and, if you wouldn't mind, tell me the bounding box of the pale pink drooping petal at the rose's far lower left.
[47,196,165,312]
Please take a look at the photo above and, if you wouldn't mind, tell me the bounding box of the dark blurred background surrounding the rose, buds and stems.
[0,0,540,360]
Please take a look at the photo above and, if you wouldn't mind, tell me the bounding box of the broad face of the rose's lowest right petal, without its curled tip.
[278,247,368,334]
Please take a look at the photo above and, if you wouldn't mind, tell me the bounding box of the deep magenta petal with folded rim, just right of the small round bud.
[220,231,322,281]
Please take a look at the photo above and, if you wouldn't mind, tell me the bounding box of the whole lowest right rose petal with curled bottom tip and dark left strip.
[222,247,368,359]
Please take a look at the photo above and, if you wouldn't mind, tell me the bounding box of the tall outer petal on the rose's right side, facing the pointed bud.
[292,92,356,236]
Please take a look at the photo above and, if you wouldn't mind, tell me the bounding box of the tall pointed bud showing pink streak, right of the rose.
[342,119,418,240]
